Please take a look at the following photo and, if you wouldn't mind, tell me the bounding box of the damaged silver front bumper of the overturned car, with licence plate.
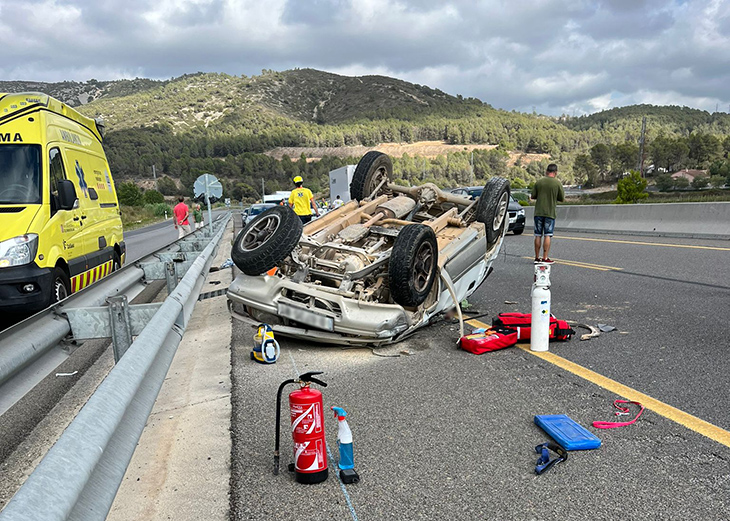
[228,275,414,345]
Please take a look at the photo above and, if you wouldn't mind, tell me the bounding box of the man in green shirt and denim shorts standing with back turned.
[532,163,565,264]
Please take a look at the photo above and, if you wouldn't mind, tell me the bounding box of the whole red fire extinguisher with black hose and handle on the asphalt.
[274,372,328,484]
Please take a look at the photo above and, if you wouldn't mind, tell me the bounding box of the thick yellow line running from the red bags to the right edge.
[468,320,730,447]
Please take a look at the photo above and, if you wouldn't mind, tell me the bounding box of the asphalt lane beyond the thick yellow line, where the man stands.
[486,233,730,430]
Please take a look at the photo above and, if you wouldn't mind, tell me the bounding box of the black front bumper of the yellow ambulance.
[0,262,53,313]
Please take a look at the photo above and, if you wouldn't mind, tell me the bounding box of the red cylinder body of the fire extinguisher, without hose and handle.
[289,386,328,483]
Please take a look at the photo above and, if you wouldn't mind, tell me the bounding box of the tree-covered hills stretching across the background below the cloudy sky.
[0,69,730,198]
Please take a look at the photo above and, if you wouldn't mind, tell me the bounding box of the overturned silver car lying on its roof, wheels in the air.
[227,152,510,345]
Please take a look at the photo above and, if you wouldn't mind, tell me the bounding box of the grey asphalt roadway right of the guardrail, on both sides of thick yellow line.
[231,230,730,520]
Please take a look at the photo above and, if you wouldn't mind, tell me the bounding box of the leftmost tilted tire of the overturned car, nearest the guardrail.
[231,206,302,275]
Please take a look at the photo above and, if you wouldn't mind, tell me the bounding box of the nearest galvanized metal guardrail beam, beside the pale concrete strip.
[0,214,230,521]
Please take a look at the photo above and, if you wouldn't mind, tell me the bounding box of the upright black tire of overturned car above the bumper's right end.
[388,224,438,307]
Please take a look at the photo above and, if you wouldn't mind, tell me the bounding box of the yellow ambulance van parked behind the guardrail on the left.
[0,92,126,313]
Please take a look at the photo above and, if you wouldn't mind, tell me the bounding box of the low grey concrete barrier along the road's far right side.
[525,202,730,240]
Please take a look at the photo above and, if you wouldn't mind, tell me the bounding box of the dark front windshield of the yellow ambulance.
[0,145,41,204]
